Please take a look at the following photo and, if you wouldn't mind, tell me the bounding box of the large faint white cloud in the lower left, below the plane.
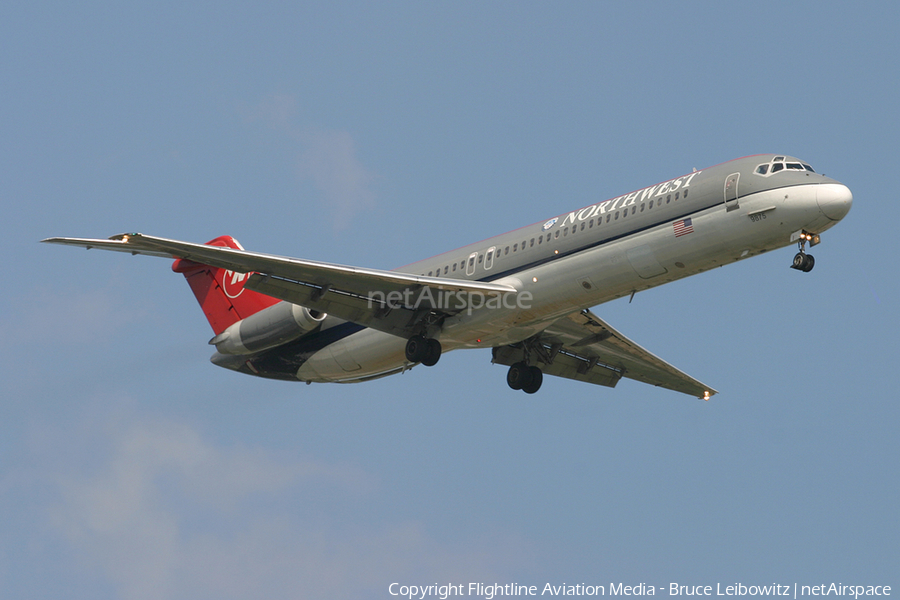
[45,410,523,600]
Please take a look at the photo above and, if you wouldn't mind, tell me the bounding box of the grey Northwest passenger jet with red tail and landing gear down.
[42,154,853,400]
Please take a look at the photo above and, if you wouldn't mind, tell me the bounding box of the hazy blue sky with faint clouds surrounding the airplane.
[0,2,900,600]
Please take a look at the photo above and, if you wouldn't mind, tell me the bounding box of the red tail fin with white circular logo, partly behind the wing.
[172,235,278,335]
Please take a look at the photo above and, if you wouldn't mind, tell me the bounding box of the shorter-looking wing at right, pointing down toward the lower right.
[494,310,717,400]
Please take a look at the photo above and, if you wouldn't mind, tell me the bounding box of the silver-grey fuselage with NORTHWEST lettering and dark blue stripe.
[212,154,852,383]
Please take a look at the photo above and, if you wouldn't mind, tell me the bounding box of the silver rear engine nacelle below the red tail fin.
[209,302,326,354]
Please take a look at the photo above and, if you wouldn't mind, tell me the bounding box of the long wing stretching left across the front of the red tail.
[43,233,517,337]
